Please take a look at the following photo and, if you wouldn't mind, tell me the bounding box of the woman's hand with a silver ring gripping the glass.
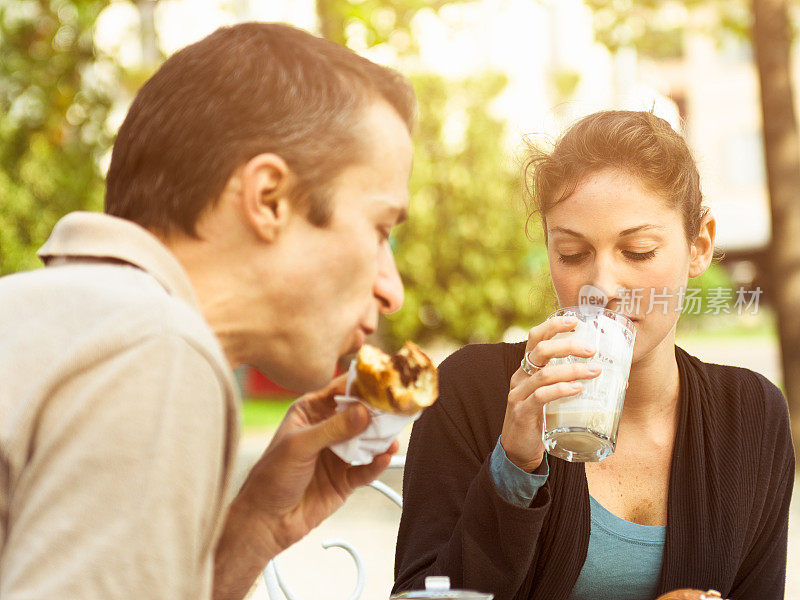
[500,317,600,473]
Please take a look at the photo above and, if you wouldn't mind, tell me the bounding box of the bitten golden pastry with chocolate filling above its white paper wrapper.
[353,342,439,415]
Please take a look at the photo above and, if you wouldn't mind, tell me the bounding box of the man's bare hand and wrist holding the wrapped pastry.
[214,376,398,600]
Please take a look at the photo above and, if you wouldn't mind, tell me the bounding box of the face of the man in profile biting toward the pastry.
[256,102,412,391]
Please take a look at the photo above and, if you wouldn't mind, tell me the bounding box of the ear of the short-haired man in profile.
[241,153,294,242]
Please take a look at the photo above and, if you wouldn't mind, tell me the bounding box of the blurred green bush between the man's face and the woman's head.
[382,73,552,347]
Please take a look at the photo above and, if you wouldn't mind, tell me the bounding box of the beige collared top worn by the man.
[0,213,239,600]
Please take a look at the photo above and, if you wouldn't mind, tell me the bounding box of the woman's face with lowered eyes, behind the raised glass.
[546,169,713,362]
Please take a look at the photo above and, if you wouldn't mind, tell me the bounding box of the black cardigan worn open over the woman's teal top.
[394,342,794,600]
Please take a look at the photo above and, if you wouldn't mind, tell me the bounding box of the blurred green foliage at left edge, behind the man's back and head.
[0,0,117,274]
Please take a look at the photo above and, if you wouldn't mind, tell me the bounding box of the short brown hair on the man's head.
[106,23,416,236]
